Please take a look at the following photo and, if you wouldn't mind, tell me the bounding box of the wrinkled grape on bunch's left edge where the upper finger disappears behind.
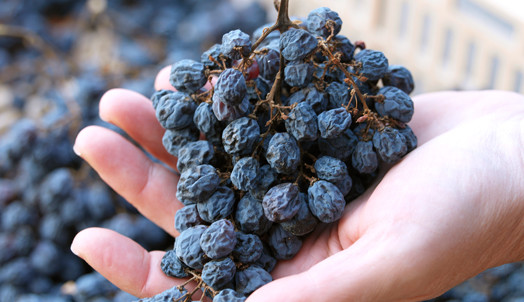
[177,141,215,173]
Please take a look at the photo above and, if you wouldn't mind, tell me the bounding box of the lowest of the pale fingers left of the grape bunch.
[71,228,179,297]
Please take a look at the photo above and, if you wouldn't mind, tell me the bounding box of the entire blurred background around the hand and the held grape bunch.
[0,0,524,302]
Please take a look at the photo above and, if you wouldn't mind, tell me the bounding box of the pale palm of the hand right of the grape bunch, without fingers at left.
[256,93,524,301]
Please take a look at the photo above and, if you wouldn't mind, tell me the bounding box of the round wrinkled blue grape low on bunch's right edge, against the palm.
[373,127,408,164]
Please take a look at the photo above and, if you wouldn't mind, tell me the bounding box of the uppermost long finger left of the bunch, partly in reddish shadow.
[99,89,177,169]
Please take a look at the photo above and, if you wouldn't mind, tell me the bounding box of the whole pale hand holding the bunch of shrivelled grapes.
[71,63,524,302]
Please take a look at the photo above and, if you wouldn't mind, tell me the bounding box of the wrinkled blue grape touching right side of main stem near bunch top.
[280,28,318,61]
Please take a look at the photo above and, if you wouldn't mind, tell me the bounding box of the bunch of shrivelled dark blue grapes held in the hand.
[142,1,417,301]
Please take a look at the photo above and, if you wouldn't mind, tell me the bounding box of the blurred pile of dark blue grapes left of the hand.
[0,0,266,302]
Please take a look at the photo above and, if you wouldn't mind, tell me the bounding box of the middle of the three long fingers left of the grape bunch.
[74,126,183,236]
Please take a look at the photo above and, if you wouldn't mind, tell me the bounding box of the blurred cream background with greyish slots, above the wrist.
[284,0,524,94]
